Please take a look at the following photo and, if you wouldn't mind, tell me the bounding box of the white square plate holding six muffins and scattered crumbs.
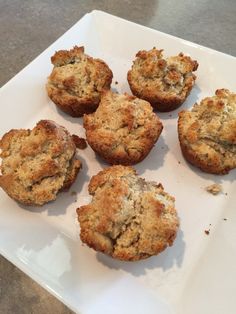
[0,11,236,314]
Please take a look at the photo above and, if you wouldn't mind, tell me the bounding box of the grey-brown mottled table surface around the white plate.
[0,0,236,314]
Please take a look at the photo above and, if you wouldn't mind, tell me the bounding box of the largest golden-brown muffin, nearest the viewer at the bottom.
[77,165,179,261]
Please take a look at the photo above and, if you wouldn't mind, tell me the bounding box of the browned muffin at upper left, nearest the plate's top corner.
[47,46,113,117]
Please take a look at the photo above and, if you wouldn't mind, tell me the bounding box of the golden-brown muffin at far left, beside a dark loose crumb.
[0,120,81,205]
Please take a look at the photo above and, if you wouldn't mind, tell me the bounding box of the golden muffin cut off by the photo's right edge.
[178,89,236,174]
